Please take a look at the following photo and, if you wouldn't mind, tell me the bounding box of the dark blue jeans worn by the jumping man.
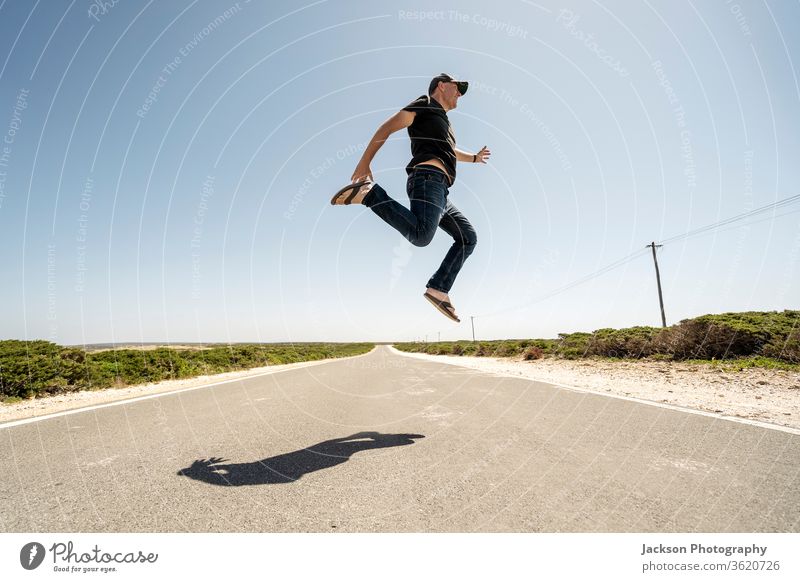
[364,166,478,293]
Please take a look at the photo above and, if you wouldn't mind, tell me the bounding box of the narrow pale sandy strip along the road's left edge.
[0,354,374,423]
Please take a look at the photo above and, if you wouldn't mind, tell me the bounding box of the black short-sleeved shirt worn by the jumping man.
[403,95,456,186]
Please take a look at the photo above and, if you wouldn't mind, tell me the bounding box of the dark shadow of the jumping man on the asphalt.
[178,432,425,487]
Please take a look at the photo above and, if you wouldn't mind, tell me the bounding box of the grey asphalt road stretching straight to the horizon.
[0,347,800,532]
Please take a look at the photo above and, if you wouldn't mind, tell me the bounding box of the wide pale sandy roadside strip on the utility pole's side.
[392,348,800,429]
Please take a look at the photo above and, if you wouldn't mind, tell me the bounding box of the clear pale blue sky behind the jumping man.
[0,0,800,344]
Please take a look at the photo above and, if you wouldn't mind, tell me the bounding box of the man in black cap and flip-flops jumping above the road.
[331,73,491,321]
